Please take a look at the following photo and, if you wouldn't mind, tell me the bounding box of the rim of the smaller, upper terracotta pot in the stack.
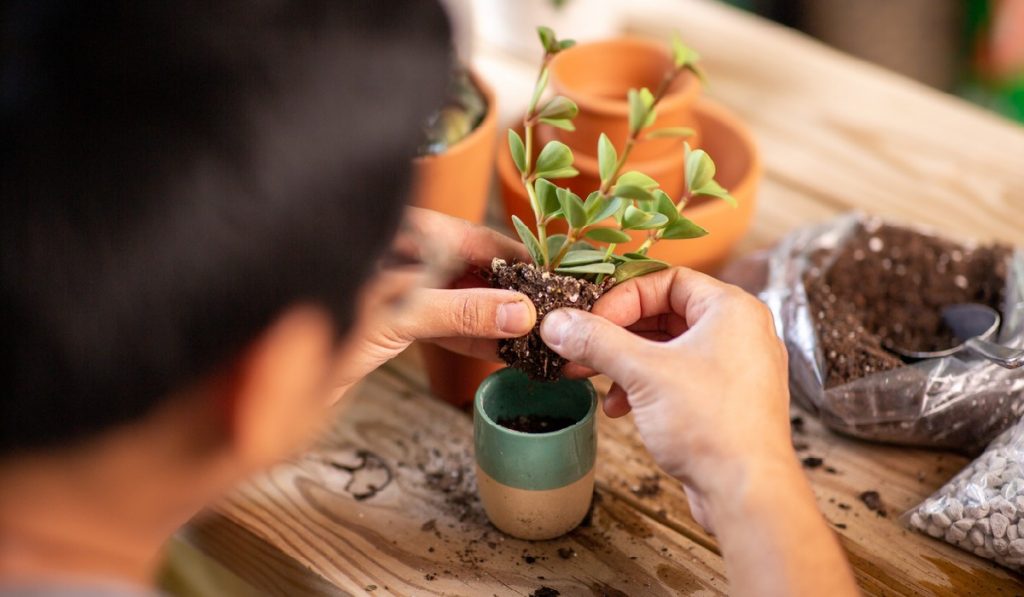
[549,37,700,118]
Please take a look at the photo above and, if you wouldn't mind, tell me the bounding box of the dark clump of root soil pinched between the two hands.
[489,259,612,381]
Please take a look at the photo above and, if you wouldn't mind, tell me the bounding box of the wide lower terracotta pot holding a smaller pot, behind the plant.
[498,100,761,271]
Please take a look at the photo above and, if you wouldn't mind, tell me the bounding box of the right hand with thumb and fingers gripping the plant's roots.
[541,268,796,514]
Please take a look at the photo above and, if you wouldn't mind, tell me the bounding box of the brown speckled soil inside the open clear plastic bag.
[804,224,1012,387]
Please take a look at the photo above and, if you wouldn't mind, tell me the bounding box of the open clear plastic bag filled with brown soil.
[746,214,1024,454]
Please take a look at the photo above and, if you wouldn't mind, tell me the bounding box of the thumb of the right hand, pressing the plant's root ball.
[541,309,649,386]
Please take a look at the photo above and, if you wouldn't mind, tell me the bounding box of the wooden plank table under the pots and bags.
[189,0,1024,595]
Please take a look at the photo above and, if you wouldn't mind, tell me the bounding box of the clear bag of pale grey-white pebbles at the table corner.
[903,420,1024,571]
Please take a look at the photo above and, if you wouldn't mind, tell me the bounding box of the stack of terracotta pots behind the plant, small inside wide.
[498,38,761,271]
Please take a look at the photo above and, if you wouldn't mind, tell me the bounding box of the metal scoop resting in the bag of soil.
[892,303,1024,369]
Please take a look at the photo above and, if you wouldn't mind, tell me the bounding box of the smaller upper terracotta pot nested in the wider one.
[550,38,701,162]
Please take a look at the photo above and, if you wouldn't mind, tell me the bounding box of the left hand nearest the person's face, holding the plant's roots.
[336,208,537,394]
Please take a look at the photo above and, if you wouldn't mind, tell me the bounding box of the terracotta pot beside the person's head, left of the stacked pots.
[412,73,498,223]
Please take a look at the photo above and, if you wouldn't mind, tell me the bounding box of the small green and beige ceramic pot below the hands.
[473,369,597,540]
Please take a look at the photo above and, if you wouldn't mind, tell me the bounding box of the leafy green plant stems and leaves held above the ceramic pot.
[508,27,735,285]
